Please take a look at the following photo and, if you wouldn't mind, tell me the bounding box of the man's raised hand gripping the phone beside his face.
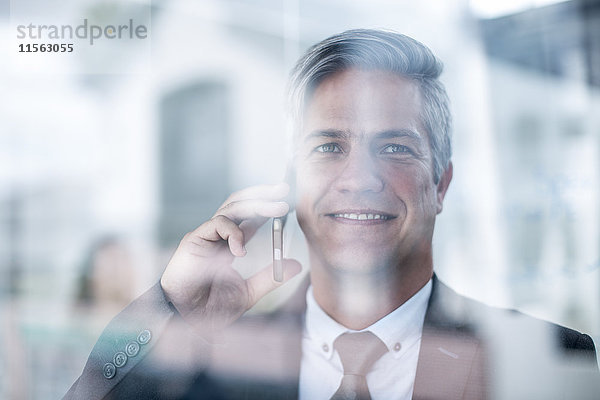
[160,183,301,335]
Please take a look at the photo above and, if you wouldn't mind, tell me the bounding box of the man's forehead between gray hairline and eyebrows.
[302,69,426,138]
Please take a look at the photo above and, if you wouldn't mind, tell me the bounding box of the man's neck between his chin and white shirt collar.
[311,253,433,330]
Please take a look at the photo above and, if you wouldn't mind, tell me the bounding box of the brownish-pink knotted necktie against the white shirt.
[331,331,388,400]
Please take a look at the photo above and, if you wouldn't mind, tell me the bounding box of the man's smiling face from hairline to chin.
[296,69,449,272]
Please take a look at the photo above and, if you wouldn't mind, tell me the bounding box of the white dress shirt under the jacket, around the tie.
[299,280,432,400]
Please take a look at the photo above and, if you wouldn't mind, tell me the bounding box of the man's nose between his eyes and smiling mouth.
[333,150,385,193]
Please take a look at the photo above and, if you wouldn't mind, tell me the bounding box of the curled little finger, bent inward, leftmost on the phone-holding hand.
[190,215,246,257]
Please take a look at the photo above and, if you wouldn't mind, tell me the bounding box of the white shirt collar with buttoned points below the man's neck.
[305,279,432,359]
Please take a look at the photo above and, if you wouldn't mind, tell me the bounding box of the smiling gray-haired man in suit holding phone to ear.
[66,30,597,399]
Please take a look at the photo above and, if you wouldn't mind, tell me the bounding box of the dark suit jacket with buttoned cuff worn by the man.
[65,276,600,399]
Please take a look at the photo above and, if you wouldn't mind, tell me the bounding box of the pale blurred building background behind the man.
[0,0,600,399]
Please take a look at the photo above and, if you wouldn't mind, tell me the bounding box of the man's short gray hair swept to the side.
[289,29,452,183]
